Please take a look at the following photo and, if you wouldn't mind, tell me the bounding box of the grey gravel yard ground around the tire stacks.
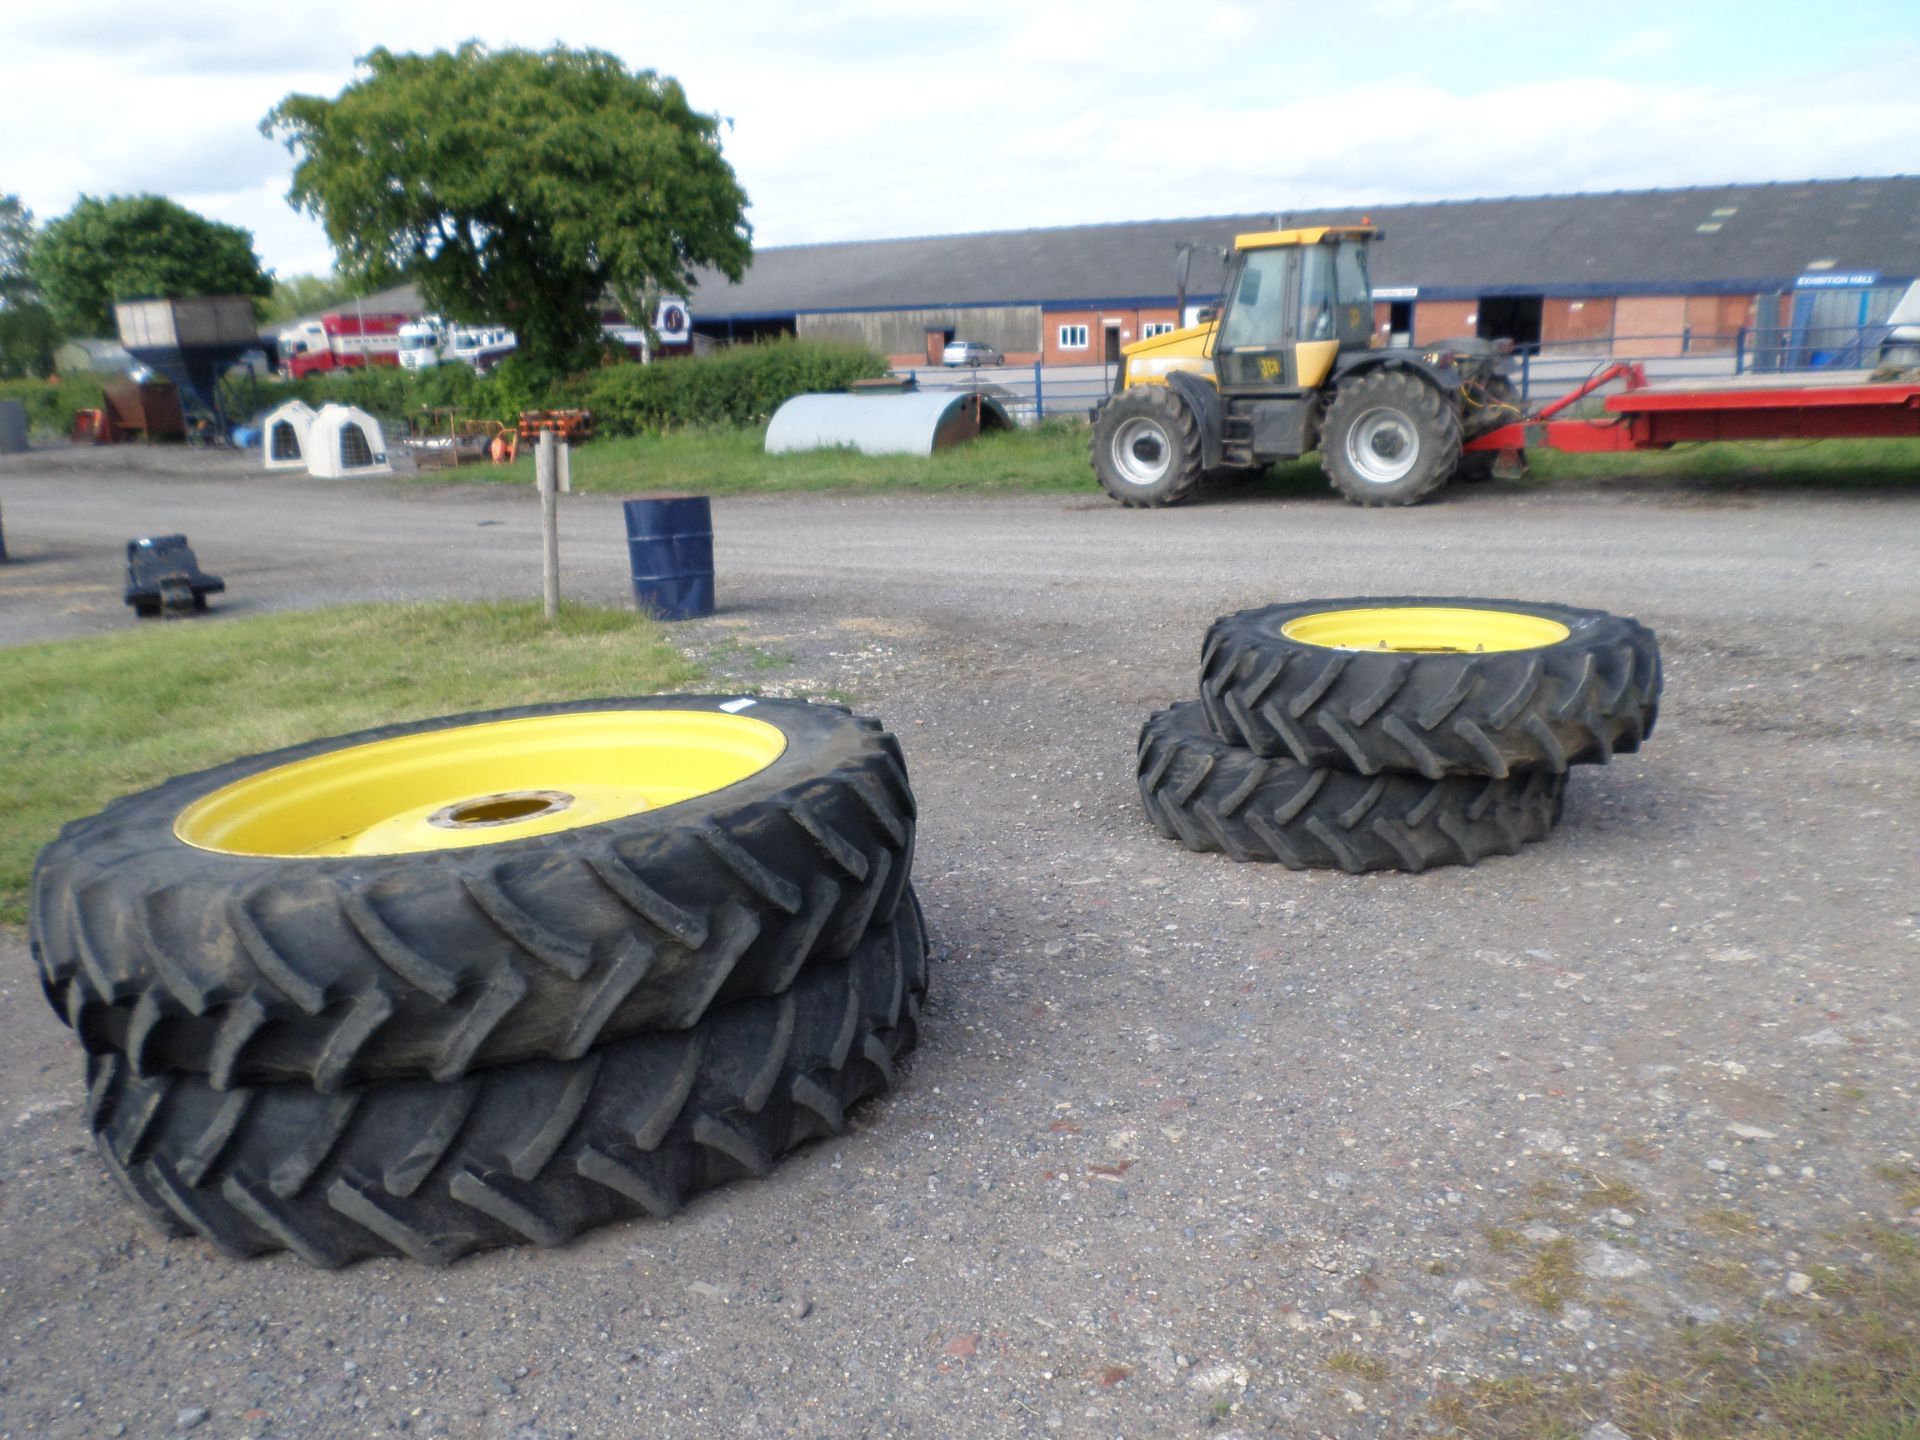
[0,449,1920,1440]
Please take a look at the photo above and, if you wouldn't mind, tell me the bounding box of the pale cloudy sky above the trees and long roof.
[11,0,1920,275]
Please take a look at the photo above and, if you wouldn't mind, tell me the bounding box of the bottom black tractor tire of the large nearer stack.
[86,891,927,1267]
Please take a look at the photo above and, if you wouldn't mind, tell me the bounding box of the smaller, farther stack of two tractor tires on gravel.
[1139,597,1661,874]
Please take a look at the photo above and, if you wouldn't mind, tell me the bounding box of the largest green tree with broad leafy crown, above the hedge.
[261,40,753,369]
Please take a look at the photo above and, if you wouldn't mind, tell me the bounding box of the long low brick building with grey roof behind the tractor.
[691,175,1920,365]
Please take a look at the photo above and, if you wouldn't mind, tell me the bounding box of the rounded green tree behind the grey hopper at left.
[31,196,273,334]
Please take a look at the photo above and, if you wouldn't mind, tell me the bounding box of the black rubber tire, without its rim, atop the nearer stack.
[29,697,914,1091]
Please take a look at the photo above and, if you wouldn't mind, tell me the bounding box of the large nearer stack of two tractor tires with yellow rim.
[31,695,927,1265]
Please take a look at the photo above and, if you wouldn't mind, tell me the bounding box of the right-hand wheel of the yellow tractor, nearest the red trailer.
[1321,369,1461,505]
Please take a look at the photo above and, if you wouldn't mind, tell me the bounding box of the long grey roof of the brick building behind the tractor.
[270,175,1920,332]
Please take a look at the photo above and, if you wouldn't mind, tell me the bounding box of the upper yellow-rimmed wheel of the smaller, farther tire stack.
[1200,597,1661,780]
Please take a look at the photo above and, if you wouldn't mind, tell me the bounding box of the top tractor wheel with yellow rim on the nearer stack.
[29,695,914,1092]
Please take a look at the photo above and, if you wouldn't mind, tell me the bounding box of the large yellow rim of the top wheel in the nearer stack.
[173,710,787,856]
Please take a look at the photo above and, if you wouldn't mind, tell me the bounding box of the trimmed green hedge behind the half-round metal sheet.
[564,340,887,436]
